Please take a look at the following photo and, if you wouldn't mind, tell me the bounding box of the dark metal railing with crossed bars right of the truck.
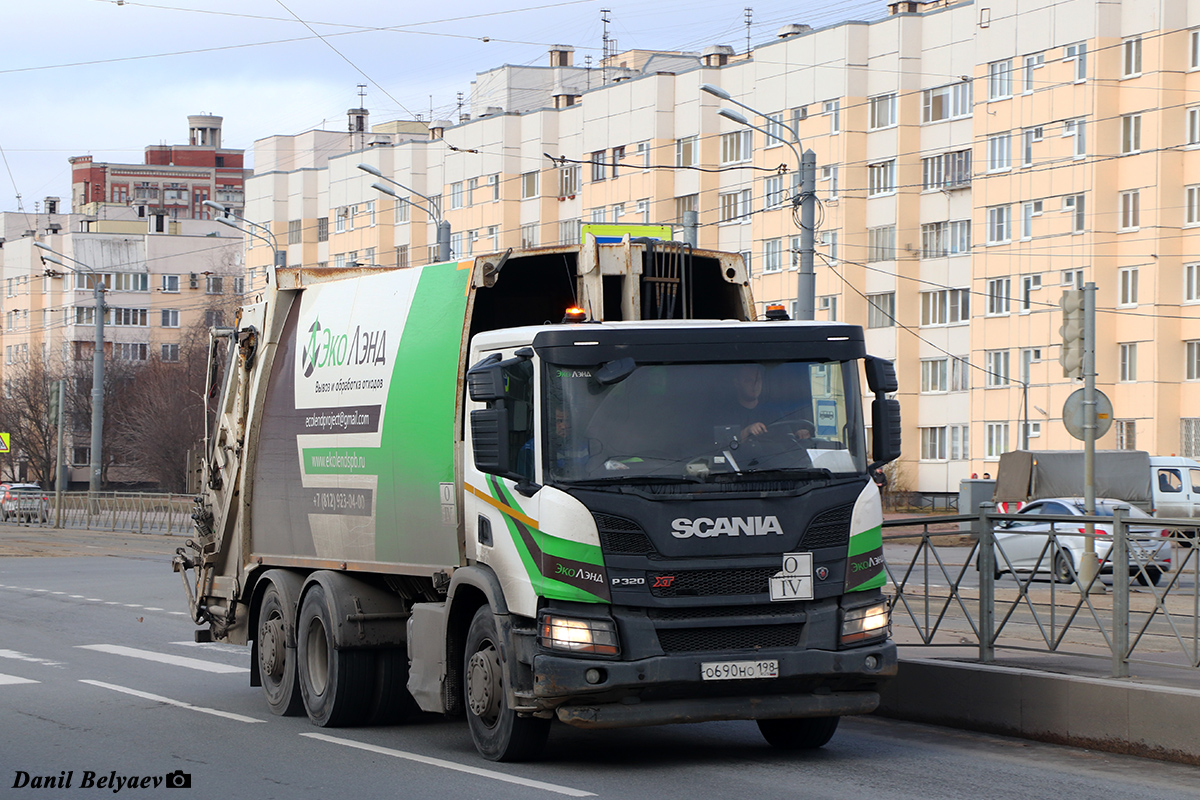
[883,504,1200,678]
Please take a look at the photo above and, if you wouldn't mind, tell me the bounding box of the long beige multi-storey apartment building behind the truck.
[246,0,1200,494]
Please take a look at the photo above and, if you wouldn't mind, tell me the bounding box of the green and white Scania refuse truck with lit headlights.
[174,236,900,760]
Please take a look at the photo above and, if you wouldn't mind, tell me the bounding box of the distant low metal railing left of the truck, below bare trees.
[11,492,194,534]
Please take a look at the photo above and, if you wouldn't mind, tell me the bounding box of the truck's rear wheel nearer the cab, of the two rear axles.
[296,583,374,728]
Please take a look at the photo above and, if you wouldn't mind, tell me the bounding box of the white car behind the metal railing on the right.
[994,498,1171,585]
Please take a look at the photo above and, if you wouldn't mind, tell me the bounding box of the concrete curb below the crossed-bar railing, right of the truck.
[875,658,1200,765]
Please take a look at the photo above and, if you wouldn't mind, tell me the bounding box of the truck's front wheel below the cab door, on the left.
[462,606,550,762]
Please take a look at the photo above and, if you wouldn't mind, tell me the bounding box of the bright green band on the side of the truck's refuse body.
[372,263,470,564]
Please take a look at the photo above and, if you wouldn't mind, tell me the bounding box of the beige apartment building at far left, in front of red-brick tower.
[0,198,246,483]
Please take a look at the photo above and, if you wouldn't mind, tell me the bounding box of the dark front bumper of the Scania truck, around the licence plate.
[533,640,896,728]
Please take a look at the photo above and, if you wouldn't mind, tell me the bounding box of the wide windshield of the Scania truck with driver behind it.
[544,361,866,482]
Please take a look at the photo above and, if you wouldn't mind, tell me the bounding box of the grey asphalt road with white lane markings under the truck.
[0,527,1200,800]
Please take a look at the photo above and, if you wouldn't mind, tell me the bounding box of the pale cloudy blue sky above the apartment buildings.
[0,0,887,211]
